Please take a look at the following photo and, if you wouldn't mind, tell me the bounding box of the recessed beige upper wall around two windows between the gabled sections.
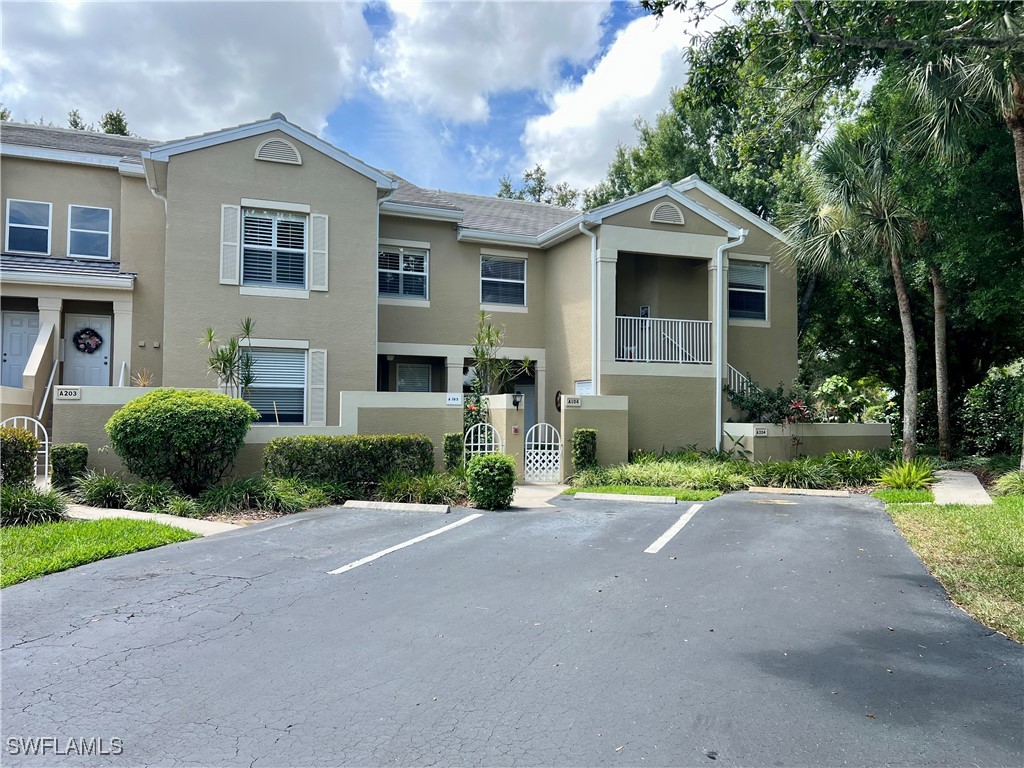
[374,215,548,347]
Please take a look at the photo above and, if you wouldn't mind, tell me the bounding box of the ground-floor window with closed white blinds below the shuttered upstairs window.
[246,347,306,424]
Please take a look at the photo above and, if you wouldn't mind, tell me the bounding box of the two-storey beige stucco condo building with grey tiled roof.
[0,114,797,450]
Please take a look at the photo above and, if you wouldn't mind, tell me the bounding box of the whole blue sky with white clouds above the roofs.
[0,0,704,195]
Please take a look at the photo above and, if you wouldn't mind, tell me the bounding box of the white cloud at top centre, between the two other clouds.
[367,0,610,123]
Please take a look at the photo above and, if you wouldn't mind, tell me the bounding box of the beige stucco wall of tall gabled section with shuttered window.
[157,131,377,424]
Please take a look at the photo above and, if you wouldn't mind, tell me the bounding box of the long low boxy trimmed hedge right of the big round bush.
[263,434,434,487]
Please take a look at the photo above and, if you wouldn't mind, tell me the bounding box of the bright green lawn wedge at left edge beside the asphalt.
[0,518,198,587]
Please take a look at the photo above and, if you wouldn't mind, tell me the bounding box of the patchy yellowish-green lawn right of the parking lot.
[889,496,1024,642]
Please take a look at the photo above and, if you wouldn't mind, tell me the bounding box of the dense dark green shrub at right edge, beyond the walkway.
[961,361,1024,456]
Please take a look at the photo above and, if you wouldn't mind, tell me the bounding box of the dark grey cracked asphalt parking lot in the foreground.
[0,494,1024,766]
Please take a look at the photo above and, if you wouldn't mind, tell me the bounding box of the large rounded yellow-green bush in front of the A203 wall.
[106,389,259,496]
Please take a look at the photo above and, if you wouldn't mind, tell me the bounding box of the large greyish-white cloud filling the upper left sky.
[0,2,373,139]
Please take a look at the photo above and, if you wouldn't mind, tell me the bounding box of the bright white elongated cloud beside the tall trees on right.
[520,13,692,187]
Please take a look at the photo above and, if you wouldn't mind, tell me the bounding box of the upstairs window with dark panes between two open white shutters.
[242,208,308,290]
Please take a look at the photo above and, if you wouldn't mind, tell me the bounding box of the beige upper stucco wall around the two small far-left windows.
[0,157,121,261]
